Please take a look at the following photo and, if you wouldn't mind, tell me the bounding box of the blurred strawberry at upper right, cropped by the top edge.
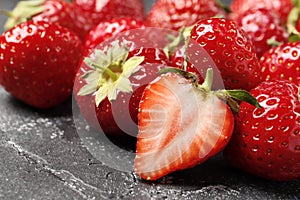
[230,0,293,23]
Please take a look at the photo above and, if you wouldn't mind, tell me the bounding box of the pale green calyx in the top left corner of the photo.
[0,0,46,30]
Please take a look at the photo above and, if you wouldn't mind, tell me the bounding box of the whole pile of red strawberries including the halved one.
[0,0,300,181]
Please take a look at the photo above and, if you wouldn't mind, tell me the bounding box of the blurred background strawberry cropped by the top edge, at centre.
[146,0,226,30]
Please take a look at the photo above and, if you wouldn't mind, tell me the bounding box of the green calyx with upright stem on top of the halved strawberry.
[160,67,261,113]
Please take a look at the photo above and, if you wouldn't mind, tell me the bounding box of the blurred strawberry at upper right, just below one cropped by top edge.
[236,8,288,57]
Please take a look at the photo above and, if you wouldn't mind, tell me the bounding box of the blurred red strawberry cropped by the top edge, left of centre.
[73,0,145,37]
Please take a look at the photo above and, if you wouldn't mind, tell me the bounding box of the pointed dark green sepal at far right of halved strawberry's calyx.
[225,90,261,108]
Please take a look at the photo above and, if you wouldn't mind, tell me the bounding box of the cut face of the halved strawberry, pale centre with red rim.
[134,73,234,180]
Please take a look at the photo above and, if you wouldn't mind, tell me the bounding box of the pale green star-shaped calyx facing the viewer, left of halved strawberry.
[78,43,145,106]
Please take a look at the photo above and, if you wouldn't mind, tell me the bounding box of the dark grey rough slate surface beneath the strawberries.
[0,0,300,200]
